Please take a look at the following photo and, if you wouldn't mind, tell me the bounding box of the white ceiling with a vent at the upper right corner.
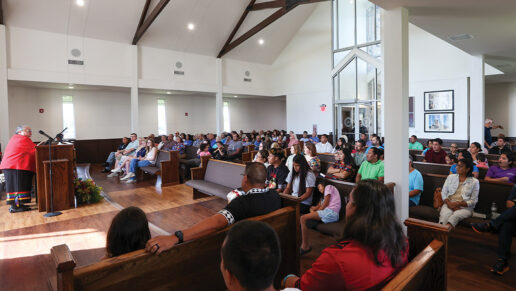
[371,0,516,82]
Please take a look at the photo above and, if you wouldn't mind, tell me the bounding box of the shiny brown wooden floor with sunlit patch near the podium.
[0,165,516,290]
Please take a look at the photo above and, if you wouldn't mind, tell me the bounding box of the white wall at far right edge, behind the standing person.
[486,83,516,137]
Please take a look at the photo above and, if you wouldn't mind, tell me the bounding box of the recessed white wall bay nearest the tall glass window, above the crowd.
[224,98,286,132]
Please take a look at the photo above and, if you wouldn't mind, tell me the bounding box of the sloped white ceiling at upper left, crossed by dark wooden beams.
[3,0,318,64]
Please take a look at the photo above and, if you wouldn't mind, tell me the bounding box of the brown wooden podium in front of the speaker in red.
[36,144,75,212]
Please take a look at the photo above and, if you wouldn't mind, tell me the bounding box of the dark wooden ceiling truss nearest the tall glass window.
[217,0,329,58]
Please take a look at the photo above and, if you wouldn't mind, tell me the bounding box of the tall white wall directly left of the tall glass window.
[270,1,333,133]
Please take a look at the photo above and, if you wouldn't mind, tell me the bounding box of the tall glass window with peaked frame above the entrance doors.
[332,0,383,140]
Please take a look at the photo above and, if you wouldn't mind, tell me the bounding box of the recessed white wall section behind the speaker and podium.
[9,86,130,140]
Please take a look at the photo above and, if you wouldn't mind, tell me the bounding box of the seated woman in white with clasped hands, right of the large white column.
[439,159,480,227]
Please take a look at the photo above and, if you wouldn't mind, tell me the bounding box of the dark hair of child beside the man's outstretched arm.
[106,206,151,257]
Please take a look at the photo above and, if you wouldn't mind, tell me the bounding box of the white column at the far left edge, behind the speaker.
[0,25,8,150]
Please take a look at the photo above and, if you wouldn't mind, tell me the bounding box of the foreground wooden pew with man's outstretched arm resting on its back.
[49,200,300,291]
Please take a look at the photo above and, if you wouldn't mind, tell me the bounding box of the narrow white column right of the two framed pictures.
[469,56,486,147]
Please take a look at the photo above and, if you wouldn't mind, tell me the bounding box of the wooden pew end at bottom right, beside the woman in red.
[382,218,451,291]
